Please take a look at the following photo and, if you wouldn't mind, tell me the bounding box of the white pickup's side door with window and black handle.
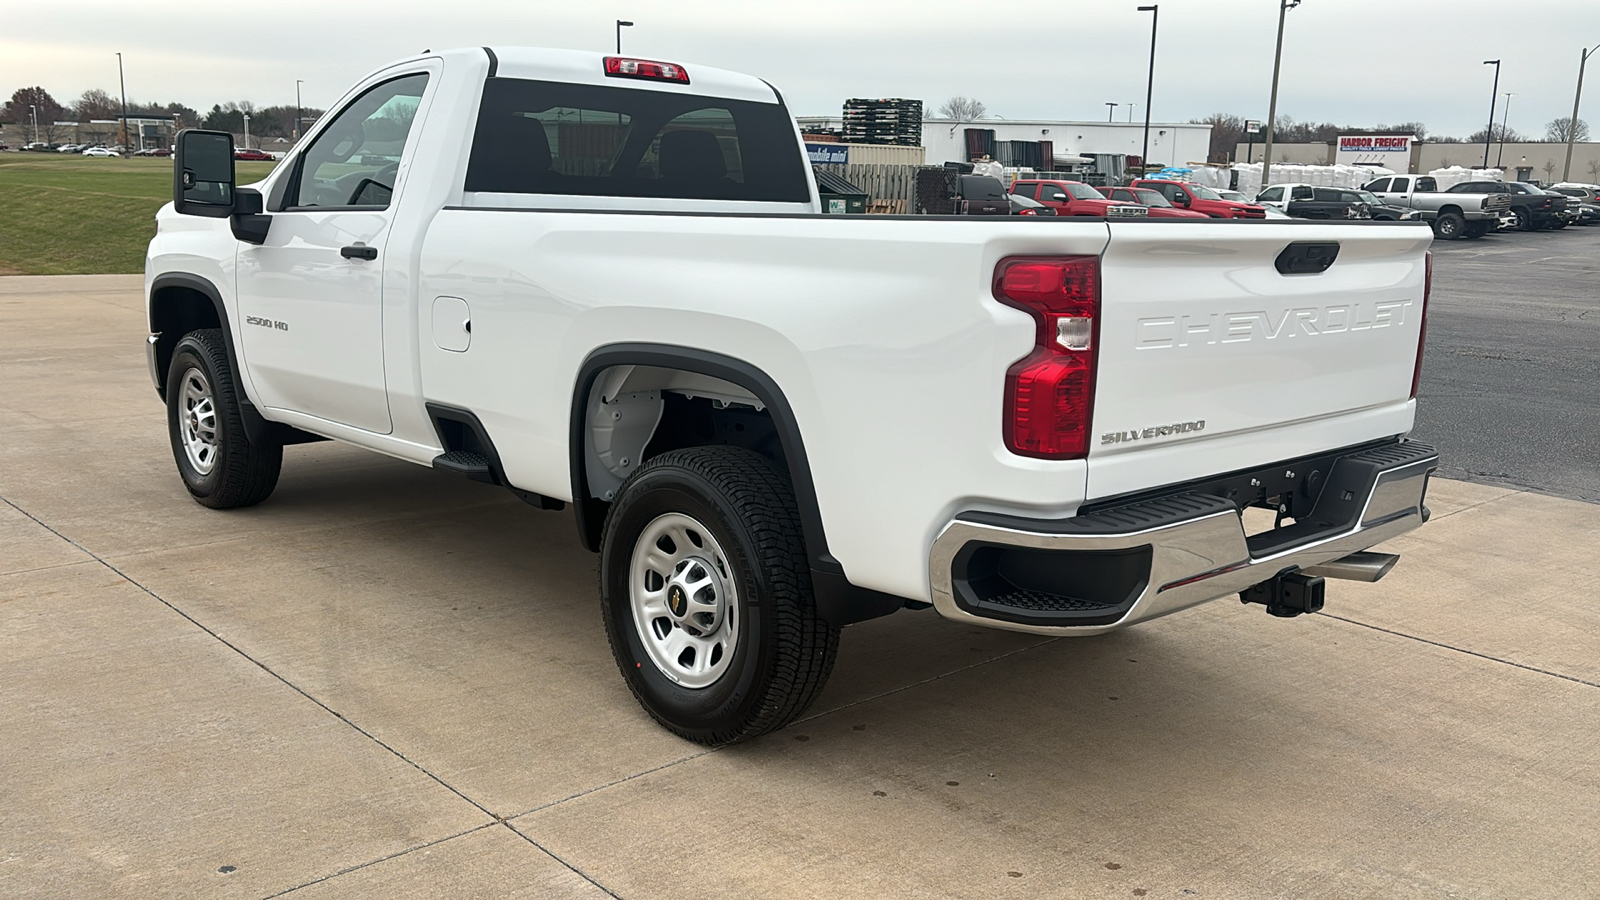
[237,72,429,434]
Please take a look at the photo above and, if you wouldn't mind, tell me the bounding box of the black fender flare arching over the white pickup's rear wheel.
[570,343,907,628]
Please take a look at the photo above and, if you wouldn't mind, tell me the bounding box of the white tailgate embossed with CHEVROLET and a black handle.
[1088,221,1432,500]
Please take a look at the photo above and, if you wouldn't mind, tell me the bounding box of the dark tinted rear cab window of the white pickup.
[466,78,811,203]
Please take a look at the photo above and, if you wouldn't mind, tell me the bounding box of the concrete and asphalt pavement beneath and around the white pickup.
[0,267,1600,898]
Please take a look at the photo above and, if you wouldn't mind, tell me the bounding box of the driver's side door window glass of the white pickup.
[285,74,427,210]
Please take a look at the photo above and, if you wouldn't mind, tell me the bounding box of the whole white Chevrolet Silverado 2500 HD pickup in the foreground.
[146,48,1437,743]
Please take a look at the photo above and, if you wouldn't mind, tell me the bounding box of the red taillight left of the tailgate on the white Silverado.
[994,256,1099,460]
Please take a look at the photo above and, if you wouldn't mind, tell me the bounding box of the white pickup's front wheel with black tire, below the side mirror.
[166,328,283,509]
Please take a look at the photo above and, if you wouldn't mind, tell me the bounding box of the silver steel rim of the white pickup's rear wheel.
[627,512,739,689]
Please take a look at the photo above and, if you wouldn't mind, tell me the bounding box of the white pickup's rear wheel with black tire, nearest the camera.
[600,447,838,745]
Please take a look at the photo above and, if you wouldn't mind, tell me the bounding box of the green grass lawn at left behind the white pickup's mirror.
[0,152,274,275]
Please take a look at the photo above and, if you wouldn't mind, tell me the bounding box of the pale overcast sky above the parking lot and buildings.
[9,0,1600,136]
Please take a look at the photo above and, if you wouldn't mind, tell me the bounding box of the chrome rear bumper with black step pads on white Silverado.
[928,442,1438,636]
